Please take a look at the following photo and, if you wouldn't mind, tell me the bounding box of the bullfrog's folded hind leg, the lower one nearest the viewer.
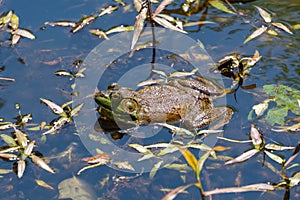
[183,106,233,129]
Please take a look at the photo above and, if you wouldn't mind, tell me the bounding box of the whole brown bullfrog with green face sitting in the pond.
[94,77,233,129]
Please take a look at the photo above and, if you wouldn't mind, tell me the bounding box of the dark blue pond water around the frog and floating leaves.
[0,0,300,199]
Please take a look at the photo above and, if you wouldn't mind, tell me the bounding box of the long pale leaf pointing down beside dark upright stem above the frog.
[130,6,148,50]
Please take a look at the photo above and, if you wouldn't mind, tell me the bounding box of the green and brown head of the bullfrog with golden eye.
[94,83,140,123]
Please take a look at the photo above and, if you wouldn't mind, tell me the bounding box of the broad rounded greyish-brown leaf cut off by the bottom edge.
[58,177,97,200]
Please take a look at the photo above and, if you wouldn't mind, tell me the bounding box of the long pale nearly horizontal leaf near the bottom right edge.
[203,183,275,196]
